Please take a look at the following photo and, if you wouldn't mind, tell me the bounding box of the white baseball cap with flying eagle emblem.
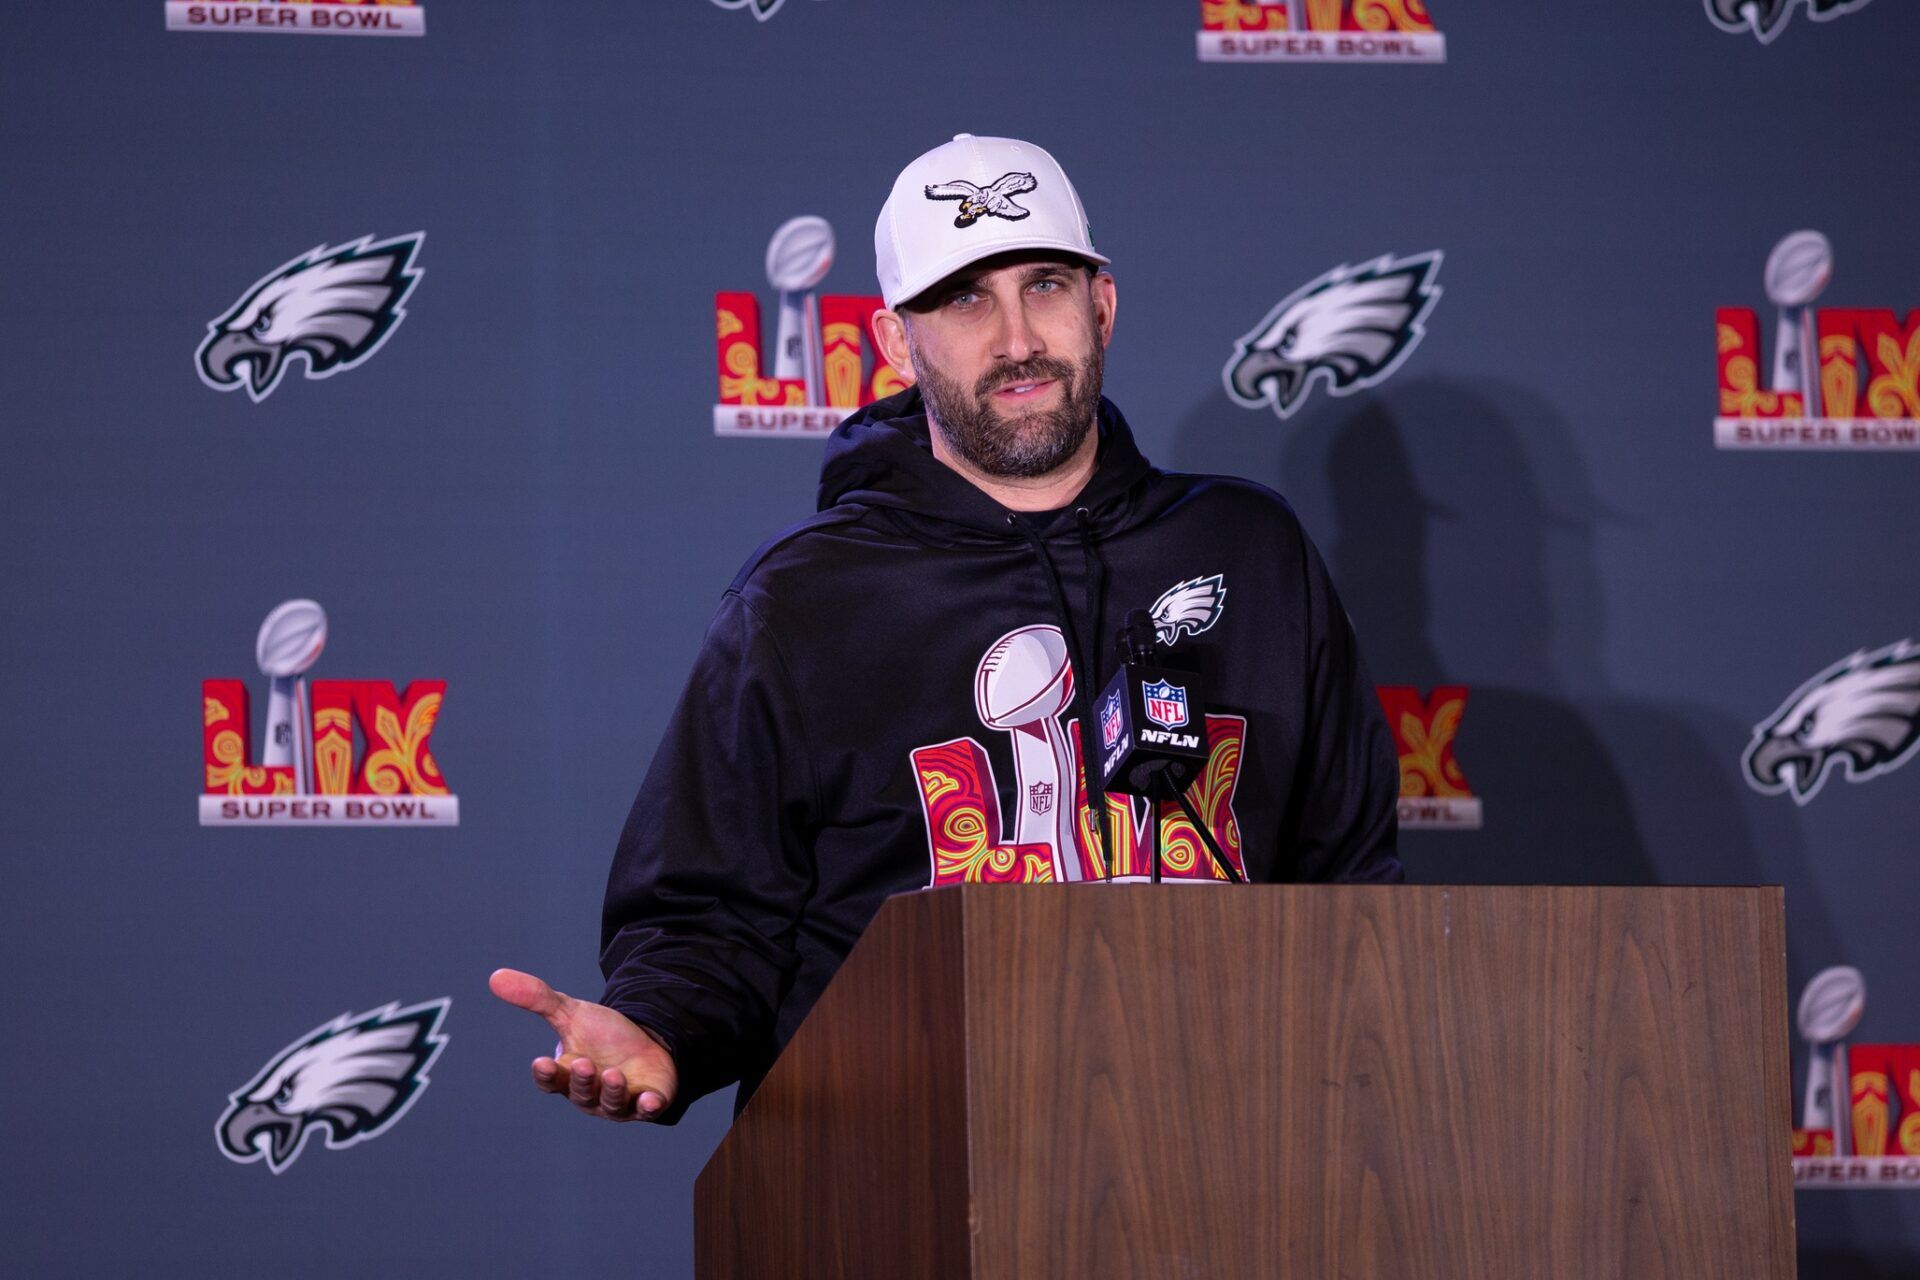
[874,132,1112,307]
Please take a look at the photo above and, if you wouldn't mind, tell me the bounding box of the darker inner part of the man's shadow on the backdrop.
[1281,380,1674,885]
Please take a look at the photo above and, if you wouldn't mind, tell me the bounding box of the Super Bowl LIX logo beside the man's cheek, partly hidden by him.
[714,217,906,438]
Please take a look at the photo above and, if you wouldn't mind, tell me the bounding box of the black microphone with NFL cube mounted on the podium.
[1094,608,1246,885]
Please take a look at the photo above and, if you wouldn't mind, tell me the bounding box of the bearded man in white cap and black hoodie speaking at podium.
[492,134,1402,1123]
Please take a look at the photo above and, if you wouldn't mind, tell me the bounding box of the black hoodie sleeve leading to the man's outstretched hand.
[601,591,816,1121]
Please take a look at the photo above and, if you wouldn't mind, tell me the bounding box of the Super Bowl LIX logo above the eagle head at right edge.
[1713,230,1920,449]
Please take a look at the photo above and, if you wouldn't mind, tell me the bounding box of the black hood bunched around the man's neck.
[820,388,1154,543]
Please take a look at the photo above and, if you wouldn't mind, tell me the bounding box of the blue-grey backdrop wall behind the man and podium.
[0,0,1920,1276]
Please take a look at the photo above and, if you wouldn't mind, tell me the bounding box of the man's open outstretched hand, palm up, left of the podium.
[488,969,680,1121]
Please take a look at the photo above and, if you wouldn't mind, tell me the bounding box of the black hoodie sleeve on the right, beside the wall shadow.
[1281,533,1405,883]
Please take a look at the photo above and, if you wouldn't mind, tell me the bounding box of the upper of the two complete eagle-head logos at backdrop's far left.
[194,230,426,405]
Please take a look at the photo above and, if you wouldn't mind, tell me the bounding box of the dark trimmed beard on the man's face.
[914,338,1106,480]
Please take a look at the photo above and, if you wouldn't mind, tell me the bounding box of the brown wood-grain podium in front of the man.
[695,885,1793,1280]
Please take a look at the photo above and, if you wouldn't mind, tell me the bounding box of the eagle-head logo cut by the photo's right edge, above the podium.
[1741,641,1920,804]
